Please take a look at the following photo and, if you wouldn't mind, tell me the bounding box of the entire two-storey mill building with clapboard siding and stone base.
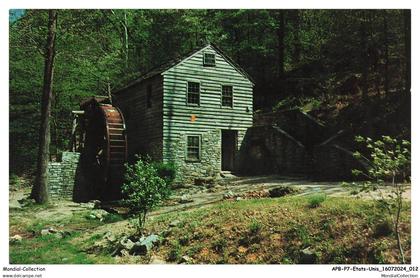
[113,44,254,182]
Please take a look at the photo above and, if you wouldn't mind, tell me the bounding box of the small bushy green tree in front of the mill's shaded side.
[122,157,171,232]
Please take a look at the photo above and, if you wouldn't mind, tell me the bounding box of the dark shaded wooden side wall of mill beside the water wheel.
[114,75,163,160]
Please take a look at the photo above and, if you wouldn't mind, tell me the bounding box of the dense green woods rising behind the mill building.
[9,10,411,174]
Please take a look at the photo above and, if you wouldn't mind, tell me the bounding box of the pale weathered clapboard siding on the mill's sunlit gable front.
[162,46,253,178]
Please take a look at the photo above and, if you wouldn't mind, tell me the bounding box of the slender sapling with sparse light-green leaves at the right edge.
[353,136,411,263]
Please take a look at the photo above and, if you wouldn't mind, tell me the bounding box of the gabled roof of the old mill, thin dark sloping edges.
[113,43,255,94]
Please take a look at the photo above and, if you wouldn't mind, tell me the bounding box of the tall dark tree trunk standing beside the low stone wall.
[31,10,57,204]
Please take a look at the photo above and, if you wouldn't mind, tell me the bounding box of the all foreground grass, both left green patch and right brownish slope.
[10,196,411,264]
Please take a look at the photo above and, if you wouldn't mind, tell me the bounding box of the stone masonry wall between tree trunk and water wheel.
[47,152,80,200]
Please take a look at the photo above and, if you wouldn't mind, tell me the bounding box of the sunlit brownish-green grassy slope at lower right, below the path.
[148,196,411,264]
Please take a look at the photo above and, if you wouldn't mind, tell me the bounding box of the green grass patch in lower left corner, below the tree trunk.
[9,206,122,264]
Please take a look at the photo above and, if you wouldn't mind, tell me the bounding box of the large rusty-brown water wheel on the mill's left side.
[82,98,127,200]
